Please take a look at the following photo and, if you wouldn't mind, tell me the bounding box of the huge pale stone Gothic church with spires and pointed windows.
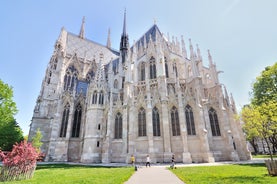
[29,13,250,163]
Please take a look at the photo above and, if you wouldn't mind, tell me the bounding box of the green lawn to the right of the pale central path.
[169,164,277,184]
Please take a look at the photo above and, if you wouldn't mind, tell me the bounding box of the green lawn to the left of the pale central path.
[0,164,134,184]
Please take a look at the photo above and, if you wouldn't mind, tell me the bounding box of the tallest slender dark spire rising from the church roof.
[120,9,129,63]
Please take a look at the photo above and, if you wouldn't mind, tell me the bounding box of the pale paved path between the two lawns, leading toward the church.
[125,165,184,184]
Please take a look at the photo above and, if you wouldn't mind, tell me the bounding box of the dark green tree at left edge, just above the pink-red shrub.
[0,119,24,151]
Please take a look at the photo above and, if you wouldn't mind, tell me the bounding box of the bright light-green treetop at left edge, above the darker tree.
[0,79,17,125]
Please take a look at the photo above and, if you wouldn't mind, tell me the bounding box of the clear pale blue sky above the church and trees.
[0,0,277,135]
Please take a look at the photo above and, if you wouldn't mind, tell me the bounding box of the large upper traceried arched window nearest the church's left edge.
[64,66,78,91]
